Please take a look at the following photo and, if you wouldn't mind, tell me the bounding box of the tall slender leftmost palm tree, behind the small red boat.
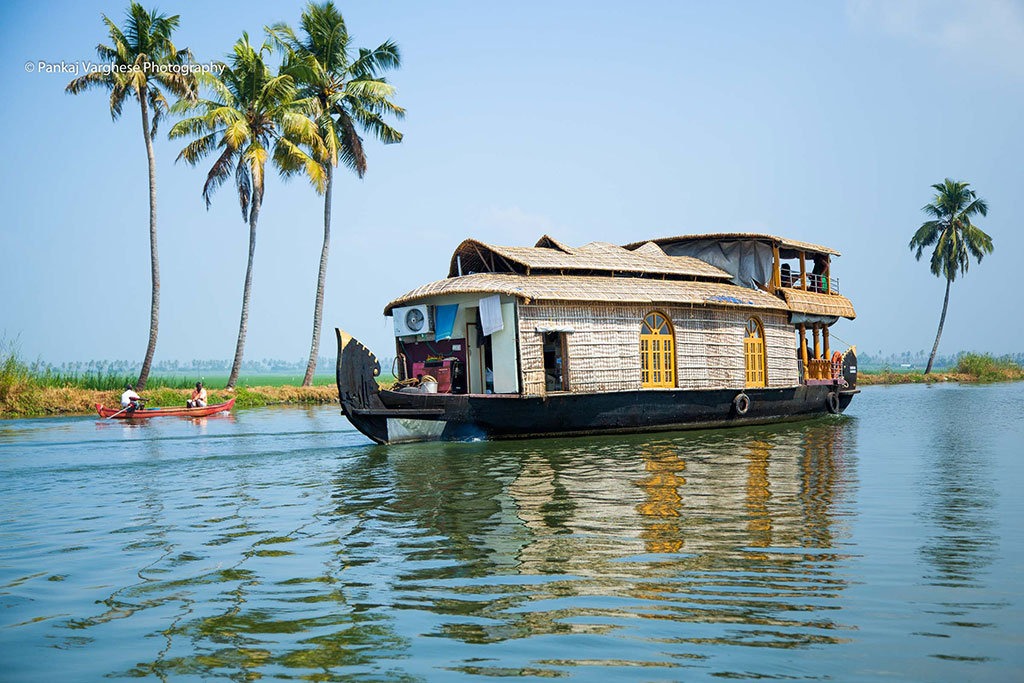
[66,2,196,390]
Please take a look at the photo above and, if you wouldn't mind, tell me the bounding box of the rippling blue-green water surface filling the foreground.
[0,383,1024,681]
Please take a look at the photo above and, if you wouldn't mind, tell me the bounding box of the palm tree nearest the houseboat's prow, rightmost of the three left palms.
[268,1,406,386]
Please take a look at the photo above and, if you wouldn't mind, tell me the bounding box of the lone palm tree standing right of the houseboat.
[909,178,993,375]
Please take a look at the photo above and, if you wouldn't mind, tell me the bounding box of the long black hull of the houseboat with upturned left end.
[338,331,856,443]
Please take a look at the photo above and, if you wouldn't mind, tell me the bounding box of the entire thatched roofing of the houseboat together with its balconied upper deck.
[385,232,856,324]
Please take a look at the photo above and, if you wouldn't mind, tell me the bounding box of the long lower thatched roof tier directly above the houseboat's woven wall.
[384,273,790,315]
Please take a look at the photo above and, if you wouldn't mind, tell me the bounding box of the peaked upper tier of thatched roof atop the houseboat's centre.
[449,236,732,282]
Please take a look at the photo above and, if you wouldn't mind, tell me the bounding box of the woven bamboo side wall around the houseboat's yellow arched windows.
[519,304,798,394]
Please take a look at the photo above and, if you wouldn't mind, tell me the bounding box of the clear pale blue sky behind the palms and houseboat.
[0,0,1024,362]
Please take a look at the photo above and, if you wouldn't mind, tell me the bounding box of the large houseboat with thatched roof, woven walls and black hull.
[337,232,858,443]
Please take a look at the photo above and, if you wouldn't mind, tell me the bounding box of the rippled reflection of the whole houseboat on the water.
[388,421,856,648]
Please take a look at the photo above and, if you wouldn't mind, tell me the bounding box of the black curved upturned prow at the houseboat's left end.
[335,328,388,443]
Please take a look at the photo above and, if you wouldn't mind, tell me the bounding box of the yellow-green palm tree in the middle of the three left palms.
[170,34,326,389]
